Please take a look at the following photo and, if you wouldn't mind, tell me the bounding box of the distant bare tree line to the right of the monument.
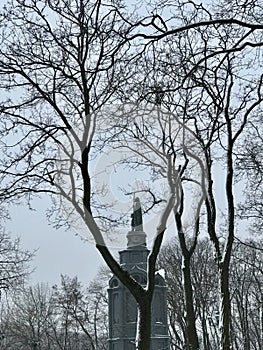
[159,239,263,350]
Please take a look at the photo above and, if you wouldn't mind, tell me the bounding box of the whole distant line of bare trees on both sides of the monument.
[0,239,263,350]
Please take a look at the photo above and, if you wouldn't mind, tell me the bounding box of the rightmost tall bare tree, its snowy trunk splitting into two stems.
[141,2,262,349]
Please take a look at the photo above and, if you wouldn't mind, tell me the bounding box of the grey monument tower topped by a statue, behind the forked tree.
[108,198,170,350]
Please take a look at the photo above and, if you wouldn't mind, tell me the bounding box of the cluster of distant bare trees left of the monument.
[1,273,109,350]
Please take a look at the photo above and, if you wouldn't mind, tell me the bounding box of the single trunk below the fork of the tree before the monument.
[136,295,151,350]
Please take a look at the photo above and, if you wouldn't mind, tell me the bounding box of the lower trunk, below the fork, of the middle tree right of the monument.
[182,257,199,350]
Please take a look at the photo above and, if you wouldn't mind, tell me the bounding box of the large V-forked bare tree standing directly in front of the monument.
[0,0,174,350]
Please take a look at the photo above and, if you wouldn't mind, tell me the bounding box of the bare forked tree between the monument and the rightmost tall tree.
[103,100,206,349]
